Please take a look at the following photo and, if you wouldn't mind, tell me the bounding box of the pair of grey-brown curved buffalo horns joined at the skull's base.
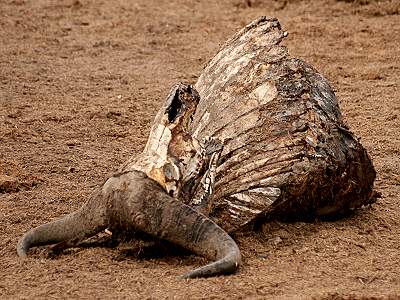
[17,171,241,278]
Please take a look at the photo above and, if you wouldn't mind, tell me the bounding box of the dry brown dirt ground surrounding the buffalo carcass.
[0,0,400,299]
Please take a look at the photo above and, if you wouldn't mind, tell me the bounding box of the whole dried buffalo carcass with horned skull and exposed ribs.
[17,17,375,278]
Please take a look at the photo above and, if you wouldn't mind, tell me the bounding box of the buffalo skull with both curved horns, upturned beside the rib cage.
[17,84,241,278]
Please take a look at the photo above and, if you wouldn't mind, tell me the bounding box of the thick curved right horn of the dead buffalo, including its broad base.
[110,172,241,278]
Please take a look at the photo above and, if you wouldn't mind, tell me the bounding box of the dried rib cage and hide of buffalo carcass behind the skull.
[190,17,375,232]
